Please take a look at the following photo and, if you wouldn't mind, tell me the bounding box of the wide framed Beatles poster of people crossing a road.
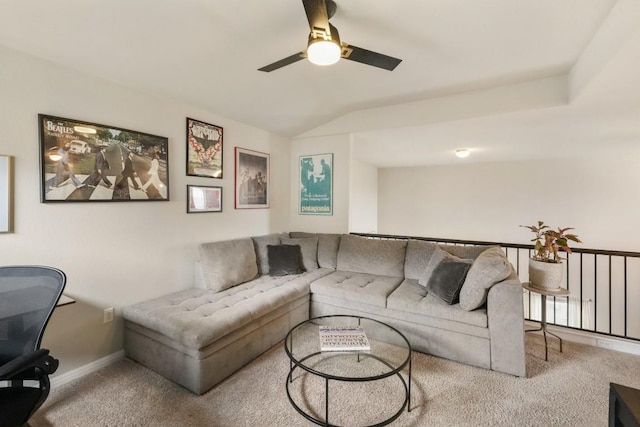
[38,114,169,203]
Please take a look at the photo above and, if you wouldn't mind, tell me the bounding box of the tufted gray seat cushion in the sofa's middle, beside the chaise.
[311,271,402,307]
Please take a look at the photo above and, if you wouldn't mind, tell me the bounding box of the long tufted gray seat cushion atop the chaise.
[123,269,332,349]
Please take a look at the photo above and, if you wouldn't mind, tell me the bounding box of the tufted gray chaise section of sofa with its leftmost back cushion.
[123,239,331,394]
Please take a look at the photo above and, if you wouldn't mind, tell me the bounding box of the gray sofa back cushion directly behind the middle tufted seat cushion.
[337,234,407,277]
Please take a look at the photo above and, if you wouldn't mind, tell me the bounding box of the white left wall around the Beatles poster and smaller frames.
[0,48,290,374]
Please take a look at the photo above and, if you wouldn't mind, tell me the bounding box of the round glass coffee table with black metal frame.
[284,315,411,427]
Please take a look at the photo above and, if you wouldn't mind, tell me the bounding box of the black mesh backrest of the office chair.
[0,266,67,365]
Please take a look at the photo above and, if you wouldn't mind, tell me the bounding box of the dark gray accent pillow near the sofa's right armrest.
[426,257,471,305]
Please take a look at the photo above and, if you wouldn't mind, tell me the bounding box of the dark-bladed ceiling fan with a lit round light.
[258,0,402,73]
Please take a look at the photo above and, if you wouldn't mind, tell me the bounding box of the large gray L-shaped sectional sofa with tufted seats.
[123,232,526,394]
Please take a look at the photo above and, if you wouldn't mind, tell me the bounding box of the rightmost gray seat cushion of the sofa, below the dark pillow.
[387,279,489,328]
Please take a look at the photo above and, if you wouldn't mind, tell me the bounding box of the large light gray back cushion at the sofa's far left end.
[199,237,258,292]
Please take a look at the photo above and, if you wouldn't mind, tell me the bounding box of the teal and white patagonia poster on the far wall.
[298,153,333,215]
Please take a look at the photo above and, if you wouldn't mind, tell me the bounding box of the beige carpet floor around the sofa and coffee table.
[30,334,640,427]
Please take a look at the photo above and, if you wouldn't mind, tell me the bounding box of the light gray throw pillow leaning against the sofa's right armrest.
[460,247,513,311]
